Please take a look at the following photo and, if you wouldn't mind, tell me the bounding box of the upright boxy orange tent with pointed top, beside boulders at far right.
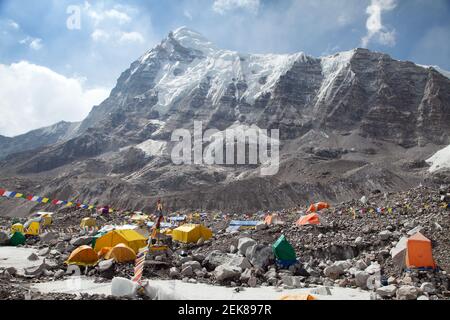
[406,232,436,269]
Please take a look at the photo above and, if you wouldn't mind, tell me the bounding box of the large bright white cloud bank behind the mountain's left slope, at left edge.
[0,61,109,136]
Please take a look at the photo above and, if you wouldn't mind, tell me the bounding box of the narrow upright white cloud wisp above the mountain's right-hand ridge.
[361,0,397,47]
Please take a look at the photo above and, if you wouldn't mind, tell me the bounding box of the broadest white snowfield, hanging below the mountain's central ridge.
[149,50,305,114]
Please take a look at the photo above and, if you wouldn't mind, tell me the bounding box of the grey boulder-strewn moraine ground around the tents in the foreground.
[0,186,450,300]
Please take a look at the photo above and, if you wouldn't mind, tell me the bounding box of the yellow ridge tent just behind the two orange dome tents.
[94,230,147,253]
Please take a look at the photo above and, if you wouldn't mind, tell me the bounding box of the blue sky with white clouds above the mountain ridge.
[0,0,450,136]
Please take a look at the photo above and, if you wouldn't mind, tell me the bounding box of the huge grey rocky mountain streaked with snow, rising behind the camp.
[0,28,450,214]
